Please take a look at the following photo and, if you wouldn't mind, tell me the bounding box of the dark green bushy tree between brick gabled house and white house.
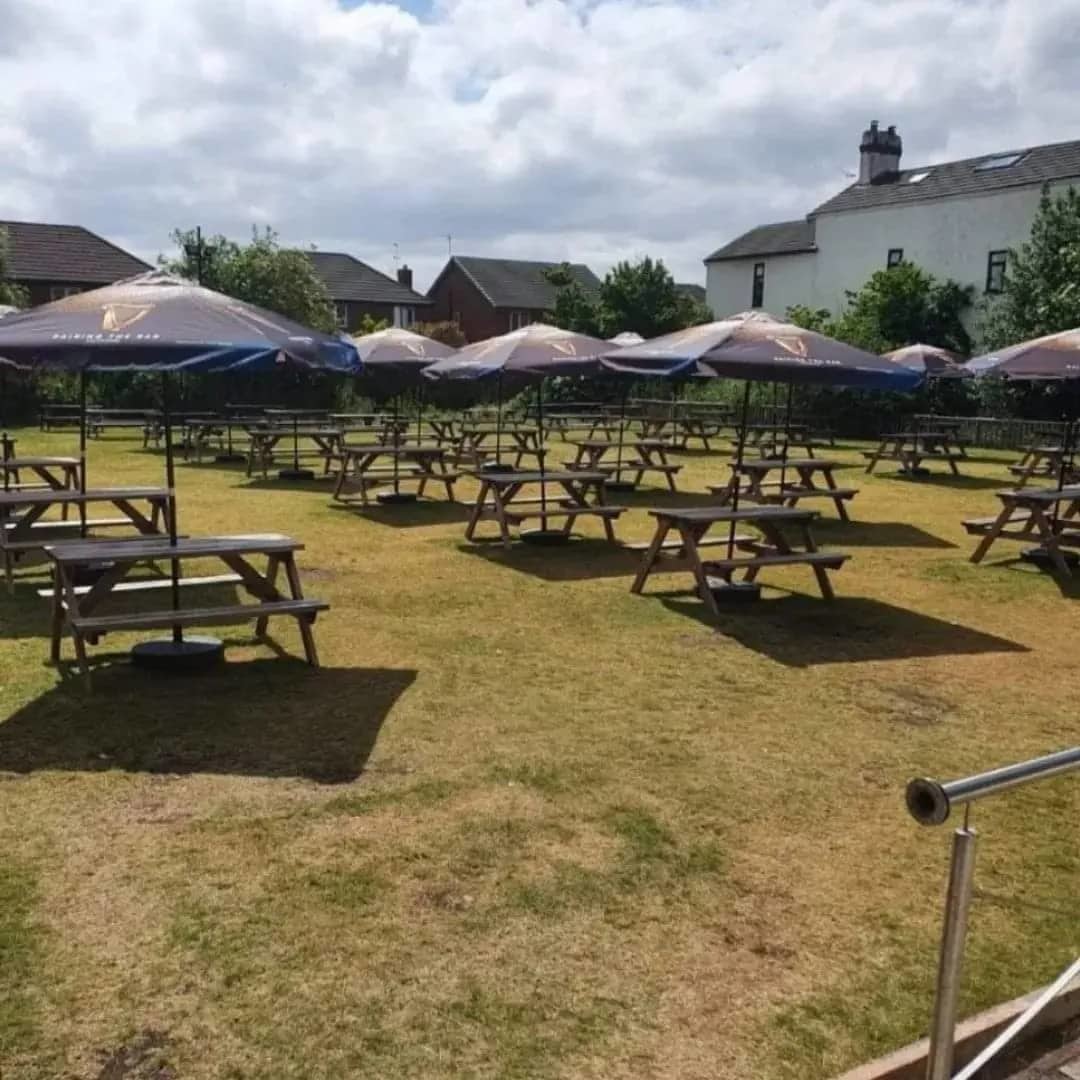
[548,256,713,338]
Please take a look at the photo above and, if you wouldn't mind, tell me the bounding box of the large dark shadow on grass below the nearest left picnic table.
[0,660,417,783]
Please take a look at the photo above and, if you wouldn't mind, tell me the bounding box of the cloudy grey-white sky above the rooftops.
[0,0,1080,286]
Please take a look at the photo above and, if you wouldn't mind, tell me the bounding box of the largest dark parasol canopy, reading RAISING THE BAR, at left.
[0,270,360,373]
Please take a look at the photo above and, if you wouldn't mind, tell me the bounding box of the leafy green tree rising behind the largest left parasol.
[159,228,335,333]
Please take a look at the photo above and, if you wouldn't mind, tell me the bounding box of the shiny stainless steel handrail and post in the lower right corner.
[905,746,1080,1080]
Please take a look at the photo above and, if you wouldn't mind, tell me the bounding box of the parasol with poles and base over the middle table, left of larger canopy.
[423,323,611,541]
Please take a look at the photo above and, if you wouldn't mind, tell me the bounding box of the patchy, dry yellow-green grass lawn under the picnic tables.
[0,431,1080,1080]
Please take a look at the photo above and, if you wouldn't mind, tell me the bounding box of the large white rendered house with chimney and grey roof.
[705,121,1080,318]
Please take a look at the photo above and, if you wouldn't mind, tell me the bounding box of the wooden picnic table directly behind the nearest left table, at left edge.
[0,487,171,591]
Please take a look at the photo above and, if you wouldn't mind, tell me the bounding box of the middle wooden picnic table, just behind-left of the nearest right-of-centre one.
[465,469,625,548]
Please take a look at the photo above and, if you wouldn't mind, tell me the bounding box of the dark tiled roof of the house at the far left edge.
[0,221,152,285]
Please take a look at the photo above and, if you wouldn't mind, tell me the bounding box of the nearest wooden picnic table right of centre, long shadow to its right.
[631,507,849,618]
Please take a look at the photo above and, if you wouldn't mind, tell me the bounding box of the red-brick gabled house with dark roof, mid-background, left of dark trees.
[428,255,600,341]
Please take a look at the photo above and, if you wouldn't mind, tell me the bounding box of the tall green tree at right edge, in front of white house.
[983,187,1080,349]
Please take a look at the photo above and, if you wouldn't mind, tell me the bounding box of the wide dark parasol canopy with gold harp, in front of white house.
[603,311,922,390]
